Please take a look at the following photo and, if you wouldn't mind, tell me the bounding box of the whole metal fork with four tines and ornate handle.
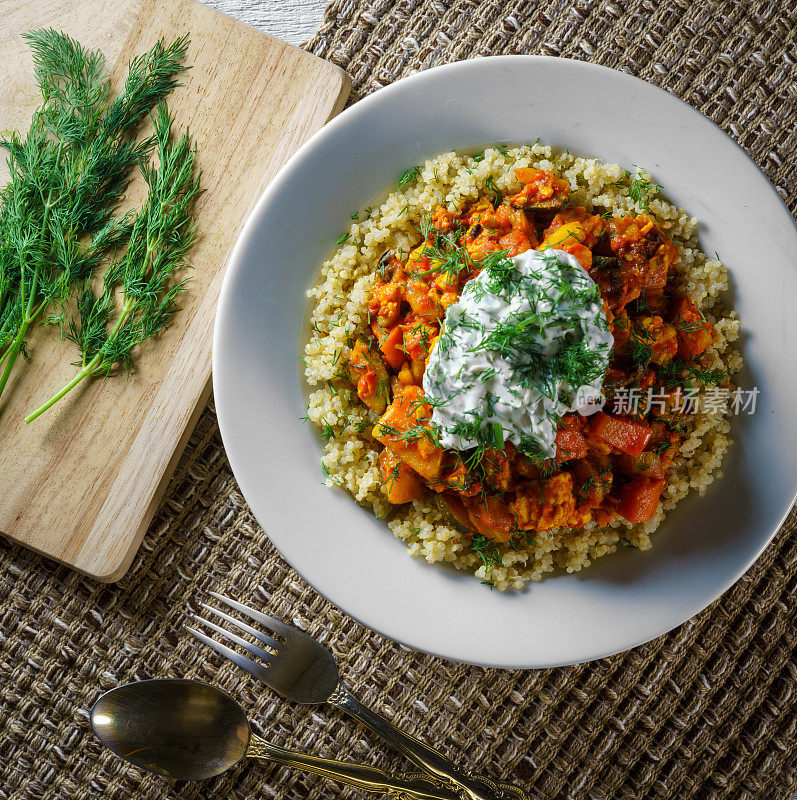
[185,592,531,800]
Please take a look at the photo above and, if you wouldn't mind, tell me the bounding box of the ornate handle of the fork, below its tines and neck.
[328,683,530,800]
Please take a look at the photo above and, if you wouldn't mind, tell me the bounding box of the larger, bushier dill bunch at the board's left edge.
[0,29,188,406]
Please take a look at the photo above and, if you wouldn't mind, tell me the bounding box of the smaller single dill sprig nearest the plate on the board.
[25,103,201,423]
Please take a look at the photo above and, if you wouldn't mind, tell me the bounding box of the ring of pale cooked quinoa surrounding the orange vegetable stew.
[304,144,741,591]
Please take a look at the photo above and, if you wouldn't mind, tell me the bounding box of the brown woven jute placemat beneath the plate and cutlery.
[0,0,797,800]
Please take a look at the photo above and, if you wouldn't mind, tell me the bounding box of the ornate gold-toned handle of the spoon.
[246,734,459,800]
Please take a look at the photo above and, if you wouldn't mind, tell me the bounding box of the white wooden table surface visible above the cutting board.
[202,0,328,45]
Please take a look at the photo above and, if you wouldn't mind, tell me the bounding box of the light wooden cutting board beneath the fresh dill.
[0,0,349,581]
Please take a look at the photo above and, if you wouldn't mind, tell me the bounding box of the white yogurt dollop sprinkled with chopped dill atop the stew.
[423,249,614,457]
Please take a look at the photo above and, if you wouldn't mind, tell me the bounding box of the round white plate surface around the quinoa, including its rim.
[213,56,797,667]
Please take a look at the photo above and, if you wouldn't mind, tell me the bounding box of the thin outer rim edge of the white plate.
[212,54,797,669]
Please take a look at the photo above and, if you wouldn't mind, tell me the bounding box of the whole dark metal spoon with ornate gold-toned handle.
[91,678,458,800]
